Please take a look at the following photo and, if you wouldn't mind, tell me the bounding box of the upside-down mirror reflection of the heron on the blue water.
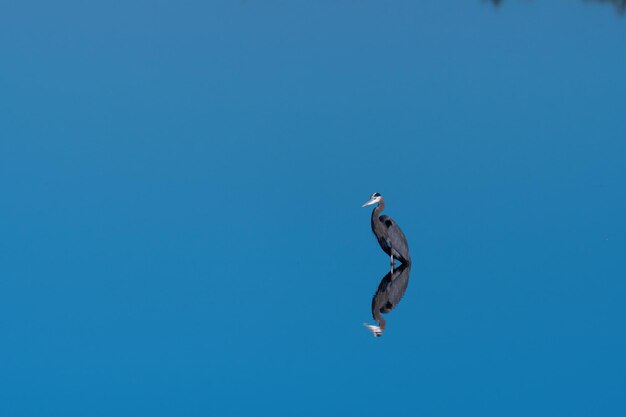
[363,263,411,337]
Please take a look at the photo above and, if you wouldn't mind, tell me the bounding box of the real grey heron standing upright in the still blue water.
[362,193,411,272]
